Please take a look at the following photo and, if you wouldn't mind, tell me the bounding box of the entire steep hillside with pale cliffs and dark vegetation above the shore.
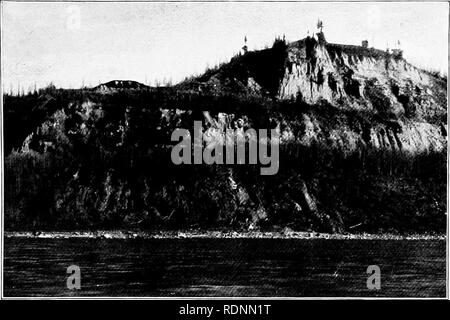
[4,38,447,233]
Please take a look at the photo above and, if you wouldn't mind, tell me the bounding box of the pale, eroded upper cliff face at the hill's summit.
[278,41,446,107]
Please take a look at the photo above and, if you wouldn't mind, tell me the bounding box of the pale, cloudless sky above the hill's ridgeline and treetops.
[1,1,449,92]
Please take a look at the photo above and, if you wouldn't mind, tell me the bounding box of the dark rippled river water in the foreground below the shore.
[3,238,446,297]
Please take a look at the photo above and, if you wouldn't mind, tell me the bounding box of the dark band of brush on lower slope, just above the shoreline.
[5,142,446,233]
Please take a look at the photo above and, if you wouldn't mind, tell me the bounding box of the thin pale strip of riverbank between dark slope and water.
[4,230,446,240]
